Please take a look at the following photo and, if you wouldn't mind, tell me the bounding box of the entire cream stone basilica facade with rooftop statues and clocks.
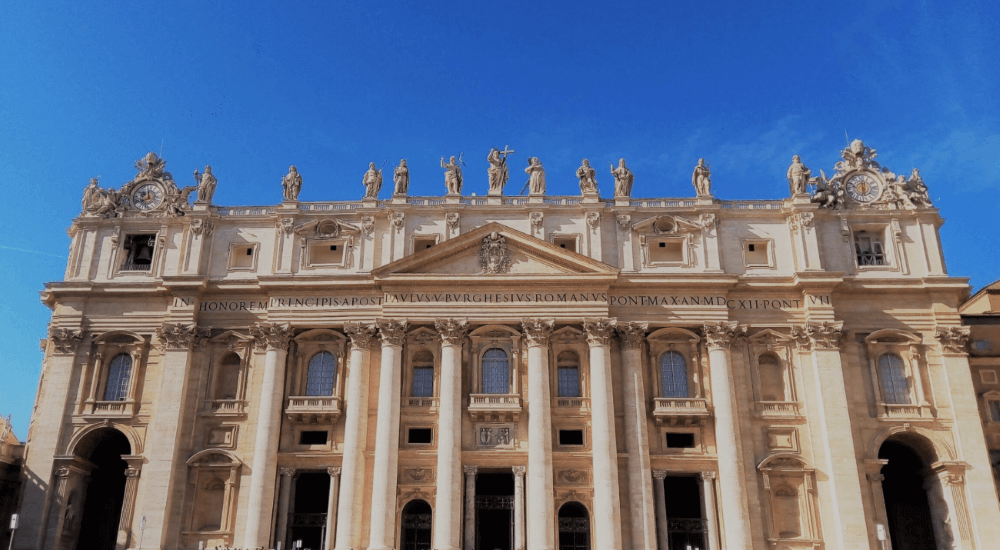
[13,141,1000,550]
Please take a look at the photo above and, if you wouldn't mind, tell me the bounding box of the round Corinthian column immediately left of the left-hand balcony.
[243,323,292,547]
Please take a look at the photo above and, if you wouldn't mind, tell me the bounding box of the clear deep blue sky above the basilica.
[0,0,1000,439]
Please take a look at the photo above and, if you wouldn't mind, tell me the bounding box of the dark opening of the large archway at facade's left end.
[73,428,132,550]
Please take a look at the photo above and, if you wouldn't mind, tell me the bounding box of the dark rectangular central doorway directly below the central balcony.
[476,473,514,550]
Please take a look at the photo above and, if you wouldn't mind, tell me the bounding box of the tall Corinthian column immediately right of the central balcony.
[521,319,560,550]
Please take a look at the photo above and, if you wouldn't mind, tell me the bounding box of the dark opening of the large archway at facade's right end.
[878,441,937,550]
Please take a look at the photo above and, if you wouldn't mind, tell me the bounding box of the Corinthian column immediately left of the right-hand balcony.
[618,323,656,548]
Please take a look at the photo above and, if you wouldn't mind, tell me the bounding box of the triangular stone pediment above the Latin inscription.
[373,222,618,279]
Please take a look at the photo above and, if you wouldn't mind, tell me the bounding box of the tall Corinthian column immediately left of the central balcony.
[433,319,469,550]
